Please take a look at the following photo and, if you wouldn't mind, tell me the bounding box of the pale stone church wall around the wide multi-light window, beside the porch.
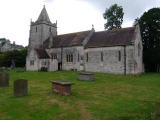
[47,46,84,70]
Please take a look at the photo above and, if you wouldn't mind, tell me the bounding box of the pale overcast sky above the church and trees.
[0,0,160,46]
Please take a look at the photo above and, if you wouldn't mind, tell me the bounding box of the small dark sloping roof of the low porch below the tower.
[35,49,49,59]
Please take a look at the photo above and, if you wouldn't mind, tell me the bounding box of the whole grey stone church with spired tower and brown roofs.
[26,6,143,74]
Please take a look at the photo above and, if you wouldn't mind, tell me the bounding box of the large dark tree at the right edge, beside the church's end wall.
[139,8,160,72]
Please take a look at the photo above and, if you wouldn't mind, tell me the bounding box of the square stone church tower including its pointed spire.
[29,6,57,50]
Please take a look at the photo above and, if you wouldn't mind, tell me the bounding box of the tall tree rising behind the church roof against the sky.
[103,4,124,30]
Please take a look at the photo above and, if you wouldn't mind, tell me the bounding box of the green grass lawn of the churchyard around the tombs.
[0,71,160,120]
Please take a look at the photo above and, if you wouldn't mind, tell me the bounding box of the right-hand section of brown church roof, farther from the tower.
[85,27,135,48]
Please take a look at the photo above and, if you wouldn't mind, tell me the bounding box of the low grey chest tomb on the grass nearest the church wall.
[78,72,95,81]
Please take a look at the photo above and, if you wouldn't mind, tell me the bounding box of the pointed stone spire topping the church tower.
[36,6,51,24]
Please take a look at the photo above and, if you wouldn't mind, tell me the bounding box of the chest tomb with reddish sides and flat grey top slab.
[51,80,73,96]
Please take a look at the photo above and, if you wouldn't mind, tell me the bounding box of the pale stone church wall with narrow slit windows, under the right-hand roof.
[85,45,142,74]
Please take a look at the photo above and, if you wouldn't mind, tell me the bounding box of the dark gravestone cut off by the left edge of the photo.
[0,72,9,87]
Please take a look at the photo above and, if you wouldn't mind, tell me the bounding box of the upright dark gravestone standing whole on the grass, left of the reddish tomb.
[14,79,28,97]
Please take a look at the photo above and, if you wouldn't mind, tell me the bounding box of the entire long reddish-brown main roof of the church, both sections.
[43,27,135,48]
